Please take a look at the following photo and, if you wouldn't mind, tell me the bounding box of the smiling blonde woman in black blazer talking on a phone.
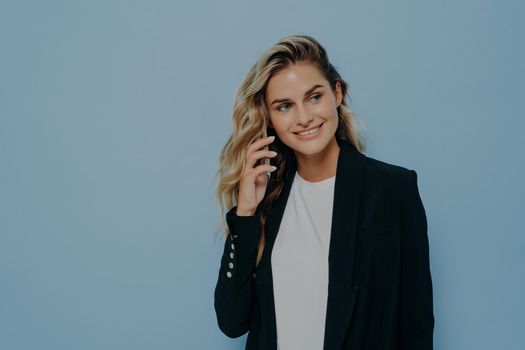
[214,35,434,350]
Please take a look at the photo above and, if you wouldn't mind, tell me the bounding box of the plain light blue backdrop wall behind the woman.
[0,0,525,350]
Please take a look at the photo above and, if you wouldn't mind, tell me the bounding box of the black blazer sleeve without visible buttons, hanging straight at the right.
[401,170,434,350]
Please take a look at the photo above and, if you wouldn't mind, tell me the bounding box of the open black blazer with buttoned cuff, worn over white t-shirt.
[214,140,434,350]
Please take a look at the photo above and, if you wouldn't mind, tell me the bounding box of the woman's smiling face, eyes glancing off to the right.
[265,62,342,157]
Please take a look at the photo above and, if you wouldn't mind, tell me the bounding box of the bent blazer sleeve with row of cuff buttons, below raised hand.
[214,206,260,338]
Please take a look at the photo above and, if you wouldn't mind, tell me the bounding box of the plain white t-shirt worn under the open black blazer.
[271,172,335,350]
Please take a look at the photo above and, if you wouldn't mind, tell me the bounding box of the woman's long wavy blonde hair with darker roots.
[214,35,366,266]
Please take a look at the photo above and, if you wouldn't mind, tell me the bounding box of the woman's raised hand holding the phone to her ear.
[236,136,277,216]
